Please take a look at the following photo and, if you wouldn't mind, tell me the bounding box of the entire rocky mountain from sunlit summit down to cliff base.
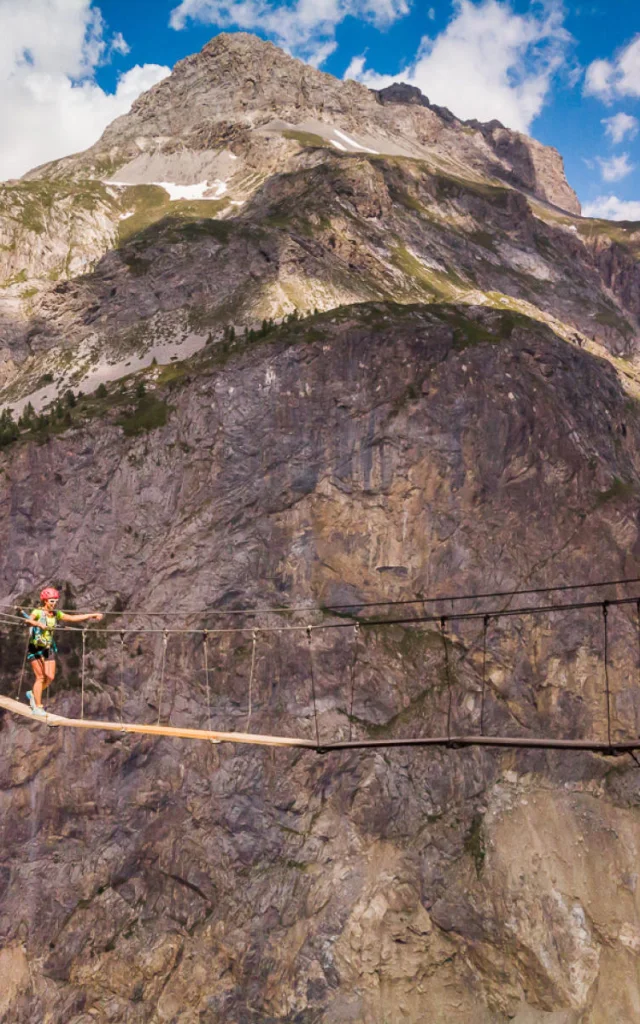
[0,34,640,1024]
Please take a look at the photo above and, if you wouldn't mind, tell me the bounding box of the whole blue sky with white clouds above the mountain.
[0,0,640,220]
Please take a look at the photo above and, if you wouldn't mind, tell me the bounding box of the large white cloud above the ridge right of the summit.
[348,0,571,131]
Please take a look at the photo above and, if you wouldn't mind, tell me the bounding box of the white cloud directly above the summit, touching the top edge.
[169,0,409,67]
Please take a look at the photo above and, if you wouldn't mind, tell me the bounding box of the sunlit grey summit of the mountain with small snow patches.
[19,32,580,220]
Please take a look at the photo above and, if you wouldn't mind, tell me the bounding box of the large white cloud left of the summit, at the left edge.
[0,0,169,180]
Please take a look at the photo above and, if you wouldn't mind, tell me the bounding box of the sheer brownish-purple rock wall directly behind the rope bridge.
[0,304,640,1024]
